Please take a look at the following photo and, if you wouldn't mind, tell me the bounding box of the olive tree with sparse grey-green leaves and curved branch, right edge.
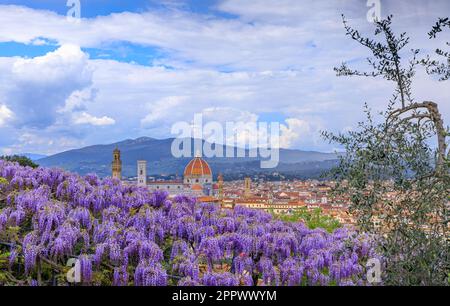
[324,16,450,285]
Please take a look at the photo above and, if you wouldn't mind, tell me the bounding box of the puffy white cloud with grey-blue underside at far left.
[2,45,92,129]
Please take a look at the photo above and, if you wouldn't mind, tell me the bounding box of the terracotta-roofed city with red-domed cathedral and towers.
[112,148,355,224]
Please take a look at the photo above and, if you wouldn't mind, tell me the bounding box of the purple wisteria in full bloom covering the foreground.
[0,160,380,286]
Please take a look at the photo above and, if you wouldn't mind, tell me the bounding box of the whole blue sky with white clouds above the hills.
[0,0,450,155]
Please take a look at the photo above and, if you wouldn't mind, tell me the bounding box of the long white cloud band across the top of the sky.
[0,0,449,71]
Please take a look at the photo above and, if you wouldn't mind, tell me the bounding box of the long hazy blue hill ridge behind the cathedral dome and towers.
[39,137,337,178]
